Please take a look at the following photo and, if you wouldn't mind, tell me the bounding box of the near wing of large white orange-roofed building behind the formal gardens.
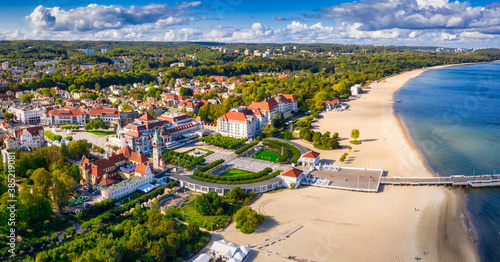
[217,107,268,139]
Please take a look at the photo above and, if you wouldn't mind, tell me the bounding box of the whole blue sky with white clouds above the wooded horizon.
[0,0,500,47]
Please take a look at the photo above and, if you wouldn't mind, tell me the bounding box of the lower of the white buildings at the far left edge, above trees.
[5,126,46,149]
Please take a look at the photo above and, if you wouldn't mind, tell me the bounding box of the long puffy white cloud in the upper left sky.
[26,2,201,32]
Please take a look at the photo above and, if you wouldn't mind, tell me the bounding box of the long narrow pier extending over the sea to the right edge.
[380,175,500,187]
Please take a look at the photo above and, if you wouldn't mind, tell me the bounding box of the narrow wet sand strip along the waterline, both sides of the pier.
[391,62,480,261]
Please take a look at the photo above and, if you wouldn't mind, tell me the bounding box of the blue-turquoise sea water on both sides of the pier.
[394,61,500,262]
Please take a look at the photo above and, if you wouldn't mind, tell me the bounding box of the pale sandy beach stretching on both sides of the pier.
[221,67,479,261]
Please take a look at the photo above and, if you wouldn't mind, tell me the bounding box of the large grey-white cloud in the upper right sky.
[319,0,500,33]
